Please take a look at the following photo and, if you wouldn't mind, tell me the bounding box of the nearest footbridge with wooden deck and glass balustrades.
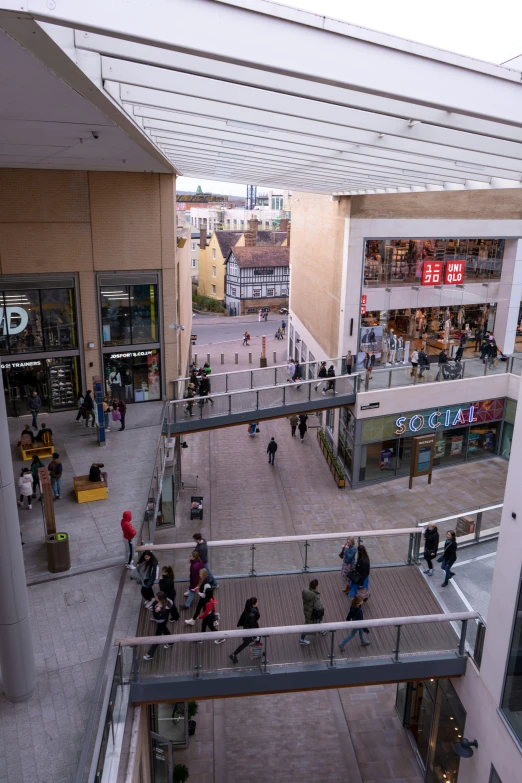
[115,528,483,703]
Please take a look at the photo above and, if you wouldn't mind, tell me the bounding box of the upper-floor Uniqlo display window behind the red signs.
[364,238,505,287]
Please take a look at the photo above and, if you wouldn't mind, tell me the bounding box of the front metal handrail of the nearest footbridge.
[114,612,482,647]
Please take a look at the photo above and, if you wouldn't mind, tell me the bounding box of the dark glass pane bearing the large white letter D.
[3,290,44,353]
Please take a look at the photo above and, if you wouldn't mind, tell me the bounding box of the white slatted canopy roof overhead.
[0,0,522,194]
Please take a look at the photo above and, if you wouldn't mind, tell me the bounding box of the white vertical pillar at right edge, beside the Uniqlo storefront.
[488,239,522,354]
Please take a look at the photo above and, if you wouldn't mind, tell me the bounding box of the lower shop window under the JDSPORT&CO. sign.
[103,348,161,402]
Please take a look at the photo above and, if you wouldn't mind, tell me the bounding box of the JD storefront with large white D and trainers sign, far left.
[0,275,82,416]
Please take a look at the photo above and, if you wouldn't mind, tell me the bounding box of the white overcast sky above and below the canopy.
[178,0,522,195]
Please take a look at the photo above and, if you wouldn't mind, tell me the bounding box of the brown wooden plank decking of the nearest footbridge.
[137,566,458,677]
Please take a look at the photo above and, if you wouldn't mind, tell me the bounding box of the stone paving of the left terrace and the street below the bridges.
[0,338,507,783]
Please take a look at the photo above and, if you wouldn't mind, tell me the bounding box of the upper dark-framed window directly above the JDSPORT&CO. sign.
[100,283,159,345]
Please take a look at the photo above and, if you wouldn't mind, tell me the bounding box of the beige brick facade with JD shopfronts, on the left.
[0,169,192,415]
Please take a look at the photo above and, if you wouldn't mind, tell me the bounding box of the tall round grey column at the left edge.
[0,373,36,701]
